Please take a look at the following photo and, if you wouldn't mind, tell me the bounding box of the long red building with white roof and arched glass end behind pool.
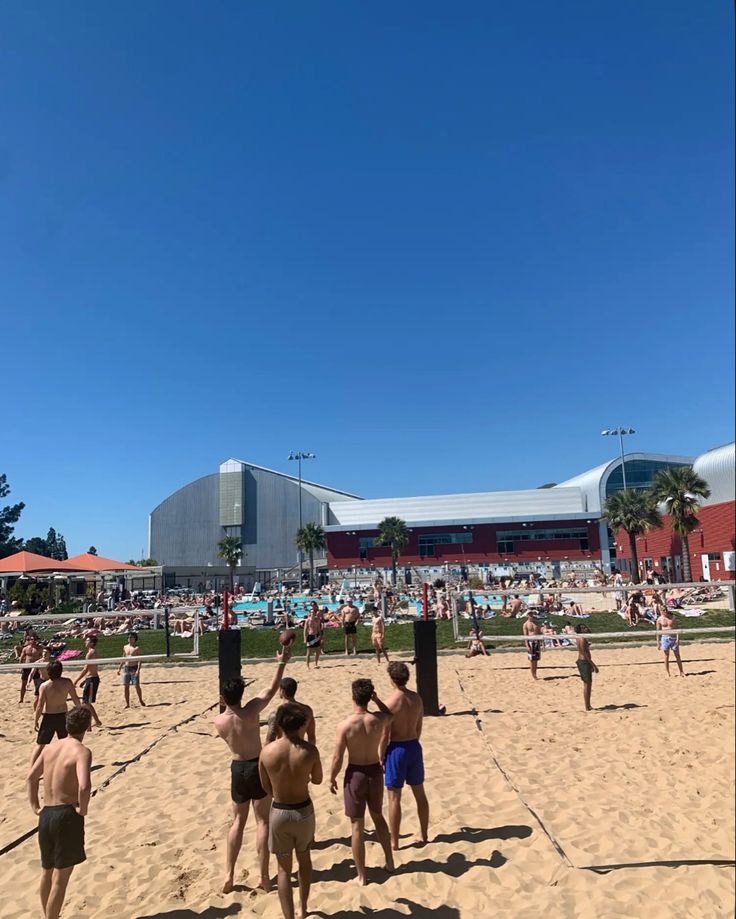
[326,447,734,580]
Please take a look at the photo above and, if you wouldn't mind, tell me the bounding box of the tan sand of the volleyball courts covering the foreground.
[0,644,735,919]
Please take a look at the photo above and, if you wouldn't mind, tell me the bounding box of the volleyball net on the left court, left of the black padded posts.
[0,607,201,673]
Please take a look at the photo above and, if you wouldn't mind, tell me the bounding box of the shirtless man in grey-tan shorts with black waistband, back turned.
[259,702,322,919]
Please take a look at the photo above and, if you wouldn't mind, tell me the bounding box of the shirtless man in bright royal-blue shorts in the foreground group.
[384,661,429,849]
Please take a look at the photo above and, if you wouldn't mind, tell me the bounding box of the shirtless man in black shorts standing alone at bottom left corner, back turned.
[27,706,92,919]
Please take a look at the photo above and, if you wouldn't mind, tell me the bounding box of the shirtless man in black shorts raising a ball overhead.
[214,648,291,893]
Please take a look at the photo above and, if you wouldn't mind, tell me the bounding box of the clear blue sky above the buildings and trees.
[0,0,734,558]
